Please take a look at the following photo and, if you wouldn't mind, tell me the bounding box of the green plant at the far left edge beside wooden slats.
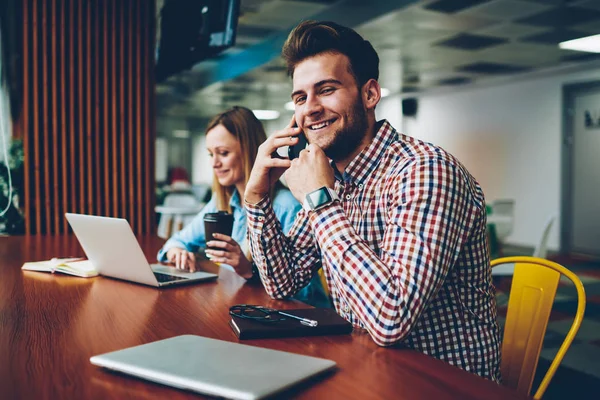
[0,140,25,235]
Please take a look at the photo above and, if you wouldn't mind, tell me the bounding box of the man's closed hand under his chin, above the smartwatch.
[285,144,335,204]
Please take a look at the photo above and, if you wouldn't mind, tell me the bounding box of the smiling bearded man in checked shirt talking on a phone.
[245,21,500,381]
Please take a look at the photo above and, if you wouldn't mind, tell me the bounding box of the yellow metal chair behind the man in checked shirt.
[491,257,585,399]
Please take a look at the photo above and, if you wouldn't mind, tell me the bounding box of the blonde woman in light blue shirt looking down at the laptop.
[158,107,330,306]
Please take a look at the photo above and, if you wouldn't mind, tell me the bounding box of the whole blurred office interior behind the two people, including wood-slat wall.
[0,0,600,253]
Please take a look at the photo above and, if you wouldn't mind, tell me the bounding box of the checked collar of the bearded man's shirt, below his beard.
[332,120,398,185]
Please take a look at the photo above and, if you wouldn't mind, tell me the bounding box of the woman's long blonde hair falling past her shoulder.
[206,106,267,212]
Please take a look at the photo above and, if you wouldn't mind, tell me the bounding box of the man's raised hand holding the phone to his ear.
[244,116,300,204]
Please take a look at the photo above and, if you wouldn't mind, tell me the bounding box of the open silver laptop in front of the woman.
[65,213,218,287]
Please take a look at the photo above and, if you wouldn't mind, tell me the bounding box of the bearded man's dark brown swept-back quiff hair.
[281,21,379,88]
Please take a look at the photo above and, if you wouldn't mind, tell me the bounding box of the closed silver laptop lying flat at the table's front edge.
[90,335,336,399]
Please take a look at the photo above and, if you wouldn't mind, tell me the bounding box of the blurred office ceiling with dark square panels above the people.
[157,0,600,130]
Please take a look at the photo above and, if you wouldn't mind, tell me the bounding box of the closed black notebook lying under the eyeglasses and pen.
[229,308,352,340]
